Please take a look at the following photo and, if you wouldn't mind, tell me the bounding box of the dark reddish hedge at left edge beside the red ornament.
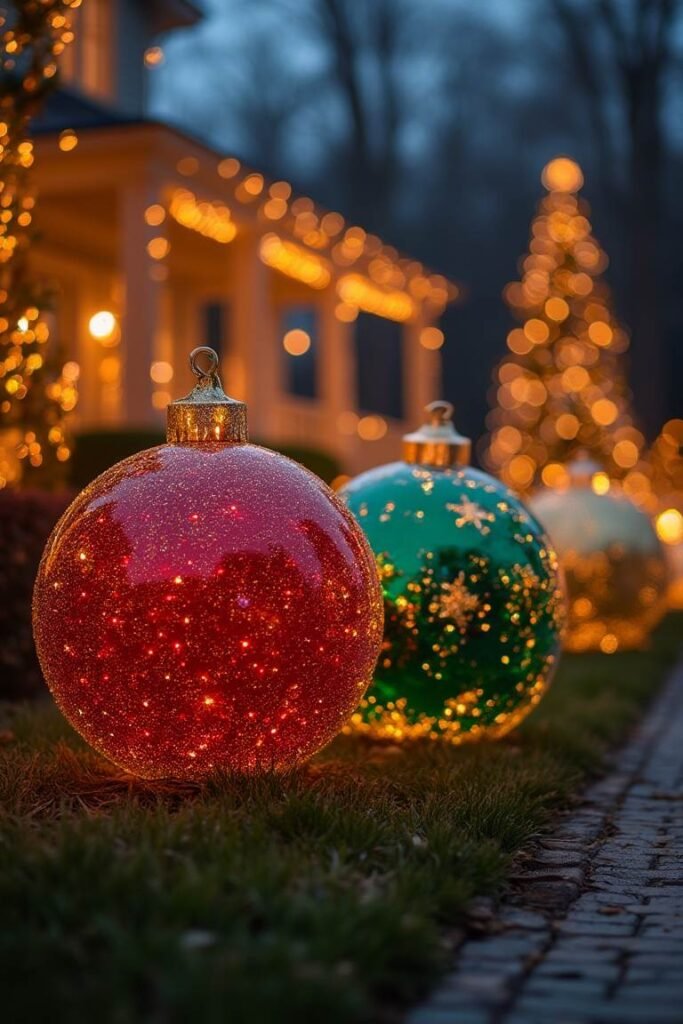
[0,490,72,698]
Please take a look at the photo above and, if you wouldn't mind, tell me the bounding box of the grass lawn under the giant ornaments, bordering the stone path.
[0,616,683,1024]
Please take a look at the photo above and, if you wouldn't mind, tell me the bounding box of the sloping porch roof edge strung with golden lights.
[31,121,459,321]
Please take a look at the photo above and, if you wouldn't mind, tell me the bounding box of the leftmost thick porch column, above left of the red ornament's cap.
[119,182,165,426]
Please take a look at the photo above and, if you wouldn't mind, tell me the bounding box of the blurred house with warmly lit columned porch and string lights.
[32,0,457,472]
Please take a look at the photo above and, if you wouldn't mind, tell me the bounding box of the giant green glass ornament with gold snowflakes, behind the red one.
[343,402,562,743]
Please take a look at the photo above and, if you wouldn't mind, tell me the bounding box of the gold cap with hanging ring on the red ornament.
[166,345,249,444]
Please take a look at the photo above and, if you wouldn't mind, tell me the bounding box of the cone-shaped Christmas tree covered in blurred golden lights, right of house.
[484,157,643,493]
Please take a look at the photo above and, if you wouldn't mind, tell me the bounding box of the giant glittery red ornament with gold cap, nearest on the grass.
[34,349,382,778]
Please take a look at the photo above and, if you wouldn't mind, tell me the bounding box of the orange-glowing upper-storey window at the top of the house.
[59,0,116,99]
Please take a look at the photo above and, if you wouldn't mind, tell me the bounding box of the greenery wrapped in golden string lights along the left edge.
[0,0,81,487]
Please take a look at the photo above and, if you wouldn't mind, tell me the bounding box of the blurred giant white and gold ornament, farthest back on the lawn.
[529,455,668,654]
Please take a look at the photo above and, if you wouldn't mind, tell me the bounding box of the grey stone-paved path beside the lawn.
[409,666,683,1024]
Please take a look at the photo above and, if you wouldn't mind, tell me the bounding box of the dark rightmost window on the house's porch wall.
[355,313,403,420]
